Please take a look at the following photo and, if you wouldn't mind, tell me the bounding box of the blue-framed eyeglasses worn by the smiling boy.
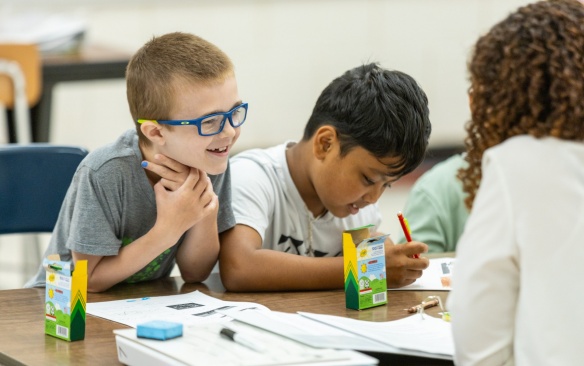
[138,103,247,136]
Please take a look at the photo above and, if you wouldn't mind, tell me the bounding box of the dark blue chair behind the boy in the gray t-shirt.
[0,143,88,278]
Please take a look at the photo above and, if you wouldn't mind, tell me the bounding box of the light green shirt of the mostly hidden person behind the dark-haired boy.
[396,154,469,253]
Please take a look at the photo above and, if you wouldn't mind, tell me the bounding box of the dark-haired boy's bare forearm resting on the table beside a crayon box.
[221,249,344,292]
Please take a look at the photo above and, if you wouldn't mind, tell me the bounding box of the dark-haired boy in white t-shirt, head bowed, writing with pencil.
[220,64,431,291]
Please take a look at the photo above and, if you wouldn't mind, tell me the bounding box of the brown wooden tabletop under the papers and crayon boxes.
[0,274,452,366]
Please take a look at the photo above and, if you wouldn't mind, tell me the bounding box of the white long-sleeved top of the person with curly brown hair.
[448,136,584,366]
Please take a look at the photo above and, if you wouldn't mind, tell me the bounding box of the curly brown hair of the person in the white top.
[458,0,584,210]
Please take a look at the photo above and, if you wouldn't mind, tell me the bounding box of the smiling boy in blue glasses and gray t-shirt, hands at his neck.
[25,33,247,292]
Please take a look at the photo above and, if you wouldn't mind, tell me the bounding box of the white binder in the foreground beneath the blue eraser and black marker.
[114,321,378,366]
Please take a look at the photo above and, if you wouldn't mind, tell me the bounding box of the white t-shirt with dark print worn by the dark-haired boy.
[230,142,381,257]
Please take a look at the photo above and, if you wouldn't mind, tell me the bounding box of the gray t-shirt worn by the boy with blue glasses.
[24,130,235,287]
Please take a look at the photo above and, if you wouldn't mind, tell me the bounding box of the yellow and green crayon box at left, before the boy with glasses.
[43,255,87,341]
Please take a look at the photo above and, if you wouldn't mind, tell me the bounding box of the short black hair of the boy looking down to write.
[302,63,432,176]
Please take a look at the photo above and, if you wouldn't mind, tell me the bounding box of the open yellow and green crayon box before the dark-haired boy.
[343,225,387,310]
